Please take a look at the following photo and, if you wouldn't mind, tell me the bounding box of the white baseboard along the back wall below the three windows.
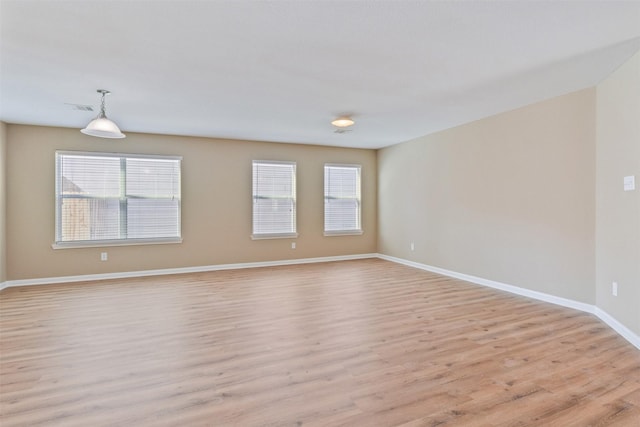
[0,254,378,290]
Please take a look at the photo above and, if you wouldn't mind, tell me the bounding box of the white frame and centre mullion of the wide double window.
[51,150,182,249]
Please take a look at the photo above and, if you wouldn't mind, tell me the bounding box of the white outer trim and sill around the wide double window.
[51,150,183,250]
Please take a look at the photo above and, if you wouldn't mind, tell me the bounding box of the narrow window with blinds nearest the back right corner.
[324,164,362,236]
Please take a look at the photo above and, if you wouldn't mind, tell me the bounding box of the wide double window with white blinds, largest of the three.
[54,151,182,248]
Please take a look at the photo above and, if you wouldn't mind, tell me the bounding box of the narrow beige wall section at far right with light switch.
[596,53,640,335]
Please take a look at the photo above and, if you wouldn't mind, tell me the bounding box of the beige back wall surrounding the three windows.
[7,124,377,280]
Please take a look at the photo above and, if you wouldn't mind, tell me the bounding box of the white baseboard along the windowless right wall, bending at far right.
[378,254,640,350]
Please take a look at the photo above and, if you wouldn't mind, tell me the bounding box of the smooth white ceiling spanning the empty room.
[0,0,640,148]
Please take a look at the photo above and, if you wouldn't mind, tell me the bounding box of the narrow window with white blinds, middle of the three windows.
[252,161,298,239]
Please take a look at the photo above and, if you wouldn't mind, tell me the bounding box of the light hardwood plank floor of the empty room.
[0,259,640,427]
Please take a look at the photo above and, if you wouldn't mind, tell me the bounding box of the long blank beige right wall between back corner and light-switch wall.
[378,89,595,304]
